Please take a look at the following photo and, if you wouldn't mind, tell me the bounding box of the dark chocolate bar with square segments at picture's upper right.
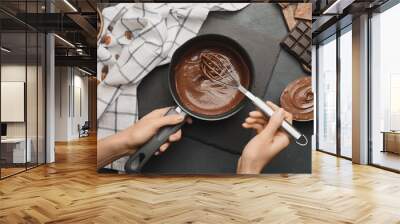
[281,22,312,68]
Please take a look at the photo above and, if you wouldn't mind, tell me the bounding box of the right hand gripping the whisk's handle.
[237,101,292,174]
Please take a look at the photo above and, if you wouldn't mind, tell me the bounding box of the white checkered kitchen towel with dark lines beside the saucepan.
[97,3,248,171]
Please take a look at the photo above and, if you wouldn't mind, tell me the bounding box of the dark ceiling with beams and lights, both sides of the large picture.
[0,0,396,71]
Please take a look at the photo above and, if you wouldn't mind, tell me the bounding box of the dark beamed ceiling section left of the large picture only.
[0,0,97,73]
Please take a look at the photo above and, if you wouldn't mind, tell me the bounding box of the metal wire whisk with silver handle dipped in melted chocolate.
[200,52,308,146]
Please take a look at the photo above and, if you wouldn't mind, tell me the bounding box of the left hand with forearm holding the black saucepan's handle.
[97,107,192,168]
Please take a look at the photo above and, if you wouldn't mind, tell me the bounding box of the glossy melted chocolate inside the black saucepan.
[175,47,250,116]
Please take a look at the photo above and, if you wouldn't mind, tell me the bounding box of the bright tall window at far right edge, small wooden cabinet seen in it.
[369,4,400,170]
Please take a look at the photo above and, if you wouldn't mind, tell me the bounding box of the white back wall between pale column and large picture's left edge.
[55,67,88,141]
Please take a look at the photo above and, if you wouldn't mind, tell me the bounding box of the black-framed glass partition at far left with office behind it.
[0,1,46,179]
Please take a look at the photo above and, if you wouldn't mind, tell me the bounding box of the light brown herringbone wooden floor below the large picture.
[0,138,400,224]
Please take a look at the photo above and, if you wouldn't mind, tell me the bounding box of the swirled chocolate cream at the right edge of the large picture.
[281,76,314,121]
